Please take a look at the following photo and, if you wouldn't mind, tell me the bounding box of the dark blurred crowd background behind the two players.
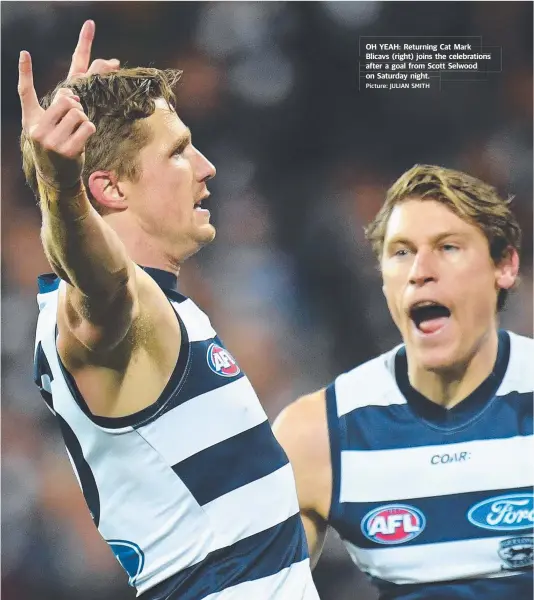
[1,2,533,600]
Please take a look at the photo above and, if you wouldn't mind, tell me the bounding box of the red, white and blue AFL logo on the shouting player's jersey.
[362,504,426,544]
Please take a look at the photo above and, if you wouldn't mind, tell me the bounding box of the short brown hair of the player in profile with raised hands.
[20,67,182,212]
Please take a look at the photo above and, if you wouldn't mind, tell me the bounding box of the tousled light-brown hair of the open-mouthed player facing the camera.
[365,165,521,310]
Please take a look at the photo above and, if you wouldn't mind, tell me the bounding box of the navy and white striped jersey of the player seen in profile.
[35,269,318,600]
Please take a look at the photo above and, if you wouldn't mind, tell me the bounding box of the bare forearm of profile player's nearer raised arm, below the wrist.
[39,178,130,303]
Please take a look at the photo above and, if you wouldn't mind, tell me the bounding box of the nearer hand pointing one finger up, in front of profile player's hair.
[18,53,96,190]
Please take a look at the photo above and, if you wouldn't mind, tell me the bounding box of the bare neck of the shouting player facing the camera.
[408,330,499,408]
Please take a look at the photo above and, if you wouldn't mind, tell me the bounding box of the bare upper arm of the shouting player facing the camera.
[273,390,332,568]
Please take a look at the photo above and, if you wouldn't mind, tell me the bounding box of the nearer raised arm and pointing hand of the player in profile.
[18,51,137,350]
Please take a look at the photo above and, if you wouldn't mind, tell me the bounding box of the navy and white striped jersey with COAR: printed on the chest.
[326,331,534,600]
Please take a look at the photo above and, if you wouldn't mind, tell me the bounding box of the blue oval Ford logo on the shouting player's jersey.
[467,492,534,531]
